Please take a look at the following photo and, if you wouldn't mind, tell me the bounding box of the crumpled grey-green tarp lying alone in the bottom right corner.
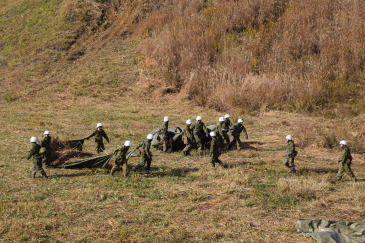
[296,219,365,243]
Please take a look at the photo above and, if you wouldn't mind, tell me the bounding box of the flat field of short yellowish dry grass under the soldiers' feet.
[0,93,365,242]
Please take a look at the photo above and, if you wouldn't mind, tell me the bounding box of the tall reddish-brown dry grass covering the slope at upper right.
[139,0,365,111]
